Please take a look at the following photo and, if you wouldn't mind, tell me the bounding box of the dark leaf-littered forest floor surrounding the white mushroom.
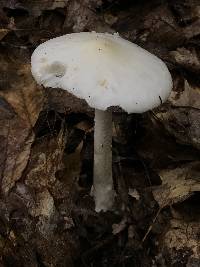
[0,0,200,267]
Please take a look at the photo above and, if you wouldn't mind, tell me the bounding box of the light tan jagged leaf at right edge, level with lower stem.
[153,162,200,207]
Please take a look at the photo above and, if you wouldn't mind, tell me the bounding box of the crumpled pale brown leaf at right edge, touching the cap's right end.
[156,80,200,149]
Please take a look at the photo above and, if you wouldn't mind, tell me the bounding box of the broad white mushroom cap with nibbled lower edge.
[31,32,172,113]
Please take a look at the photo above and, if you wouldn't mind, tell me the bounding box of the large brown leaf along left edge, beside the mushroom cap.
[0,48,44,193]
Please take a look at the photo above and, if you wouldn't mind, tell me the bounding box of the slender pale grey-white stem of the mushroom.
[93,109,115,212]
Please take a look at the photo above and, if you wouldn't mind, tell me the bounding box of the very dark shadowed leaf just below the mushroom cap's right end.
[137,114,199,169]
